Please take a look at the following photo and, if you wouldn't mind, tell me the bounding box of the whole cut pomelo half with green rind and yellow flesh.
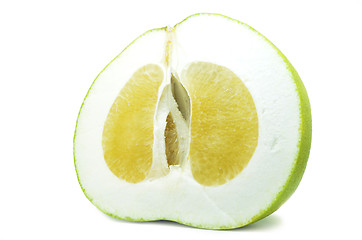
[74,14,311,229]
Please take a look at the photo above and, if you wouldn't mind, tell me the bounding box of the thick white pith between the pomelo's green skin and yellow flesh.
[75,15,300,227]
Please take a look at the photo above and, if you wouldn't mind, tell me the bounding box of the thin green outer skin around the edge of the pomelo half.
[73,13,312,229]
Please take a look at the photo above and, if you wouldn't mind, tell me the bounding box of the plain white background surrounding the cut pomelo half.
[0,0,362,239]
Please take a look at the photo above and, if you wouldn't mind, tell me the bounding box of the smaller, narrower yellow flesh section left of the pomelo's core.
[102,64,163,183]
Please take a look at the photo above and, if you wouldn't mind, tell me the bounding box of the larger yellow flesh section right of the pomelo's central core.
[182,62,258,186]
